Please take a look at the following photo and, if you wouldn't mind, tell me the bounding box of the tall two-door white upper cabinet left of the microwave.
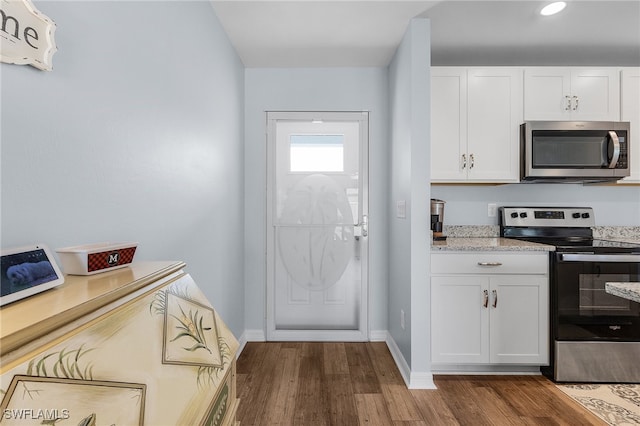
[431,67,523,182]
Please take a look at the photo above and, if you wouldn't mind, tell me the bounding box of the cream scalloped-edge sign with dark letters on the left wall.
[0,0,57,71]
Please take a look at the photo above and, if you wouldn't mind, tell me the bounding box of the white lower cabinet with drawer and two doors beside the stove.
[431,252,549,368]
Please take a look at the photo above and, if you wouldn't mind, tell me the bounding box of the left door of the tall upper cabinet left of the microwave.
[431,67,467,182]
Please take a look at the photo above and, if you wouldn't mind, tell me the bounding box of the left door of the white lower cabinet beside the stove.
[431,276,489,364]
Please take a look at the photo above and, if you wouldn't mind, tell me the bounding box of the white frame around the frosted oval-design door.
[265,111,369,342]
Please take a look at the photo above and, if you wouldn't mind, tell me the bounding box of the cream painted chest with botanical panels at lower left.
[0,263,238,426]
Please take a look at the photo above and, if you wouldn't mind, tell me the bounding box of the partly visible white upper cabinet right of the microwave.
[618,68,640,184]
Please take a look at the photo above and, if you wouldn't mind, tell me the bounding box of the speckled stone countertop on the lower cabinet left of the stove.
[431,237,555,252]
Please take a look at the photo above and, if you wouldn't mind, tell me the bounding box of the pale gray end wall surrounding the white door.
[245,68,389,332]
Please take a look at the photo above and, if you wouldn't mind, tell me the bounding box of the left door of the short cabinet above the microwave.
[524,67,571,121]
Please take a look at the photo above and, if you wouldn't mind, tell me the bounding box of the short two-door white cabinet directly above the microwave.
[524,67,620,121]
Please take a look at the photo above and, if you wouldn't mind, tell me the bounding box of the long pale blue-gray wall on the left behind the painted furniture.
[0,1,244,336]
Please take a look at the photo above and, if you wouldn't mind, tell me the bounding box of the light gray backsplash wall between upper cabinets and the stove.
[431,184,640,226]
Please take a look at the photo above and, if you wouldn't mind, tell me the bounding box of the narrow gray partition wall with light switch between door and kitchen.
[388,19,431,374]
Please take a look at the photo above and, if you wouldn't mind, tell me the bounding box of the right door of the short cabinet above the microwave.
[571,68,620,121]
